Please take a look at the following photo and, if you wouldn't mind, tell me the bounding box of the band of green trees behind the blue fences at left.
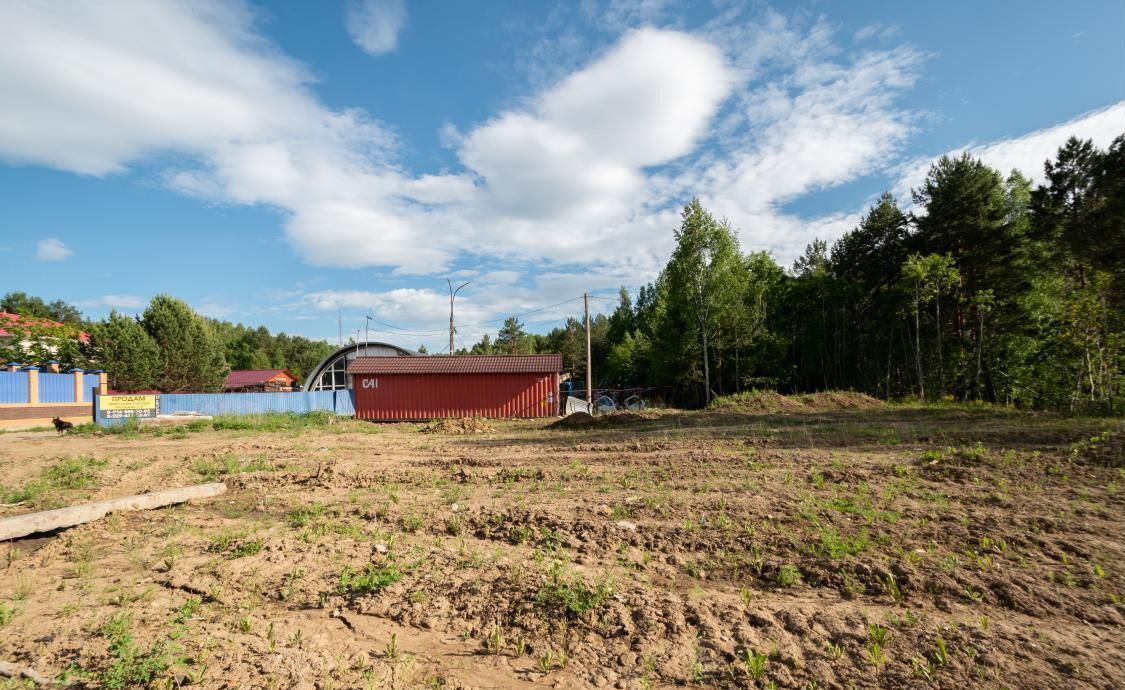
[0,292,335,392]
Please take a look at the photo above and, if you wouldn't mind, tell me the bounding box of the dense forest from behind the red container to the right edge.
[468,135,1125,413]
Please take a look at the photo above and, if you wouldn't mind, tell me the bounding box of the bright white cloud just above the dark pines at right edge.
[894,100,1125,201]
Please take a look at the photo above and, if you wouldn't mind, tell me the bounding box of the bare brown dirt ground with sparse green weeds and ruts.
[0,404,1125,690]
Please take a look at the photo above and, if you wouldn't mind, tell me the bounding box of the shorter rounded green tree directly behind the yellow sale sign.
[89,310,161,391]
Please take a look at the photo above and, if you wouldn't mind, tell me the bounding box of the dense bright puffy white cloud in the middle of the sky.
[458,29,735,261]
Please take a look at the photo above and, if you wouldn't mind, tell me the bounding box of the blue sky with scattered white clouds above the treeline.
[0,0,1125,351]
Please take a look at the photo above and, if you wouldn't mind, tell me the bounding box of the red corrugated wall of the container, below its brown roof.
[354,373,559,421]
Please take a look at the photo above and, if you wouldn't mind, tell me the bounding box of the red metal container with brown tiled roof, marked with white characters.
[348,355,563,421]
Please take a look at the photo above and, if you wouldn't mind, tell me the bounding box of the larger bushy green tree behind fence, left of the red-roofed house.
[142,295,230,393]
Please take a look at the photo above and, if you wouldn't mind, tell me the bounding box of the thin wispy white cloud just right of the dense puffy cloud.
[697,14,926,258]
